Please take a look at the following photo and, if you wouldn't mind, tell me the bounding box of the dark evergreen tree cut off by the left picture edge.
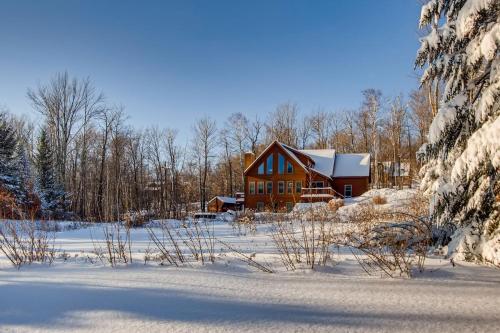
[0,113,19,196]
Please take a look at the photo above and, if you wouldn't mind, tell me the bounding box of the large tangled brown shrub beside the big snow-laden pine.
[335,195,432,277]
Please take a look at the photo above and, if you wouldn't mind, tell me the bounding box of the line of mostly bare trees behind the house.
[0,73,433,221]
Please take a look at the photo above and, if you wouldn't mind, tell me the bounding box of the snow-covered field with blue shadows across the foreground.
[0,190,500,333]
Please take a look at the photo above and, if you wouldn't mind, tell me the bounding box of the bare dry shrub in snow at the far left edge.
[0,221,55,269]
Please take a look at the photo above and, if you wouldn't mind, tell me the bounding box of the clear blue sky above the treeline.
[0,0,420,140]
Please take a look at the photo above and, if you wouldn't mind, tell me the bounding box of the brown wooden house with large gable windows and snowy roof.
[244,141,370,211]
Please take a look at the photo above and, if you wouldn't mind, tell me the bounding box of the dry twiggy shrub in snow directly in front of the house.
[272,207,334,270]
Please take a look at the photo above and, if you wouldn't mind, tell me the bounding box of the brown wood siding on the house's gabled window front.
[245,144,331,210]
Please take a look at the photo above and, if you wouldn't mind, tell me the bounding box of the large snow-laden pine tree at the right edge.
[416,0,500,265]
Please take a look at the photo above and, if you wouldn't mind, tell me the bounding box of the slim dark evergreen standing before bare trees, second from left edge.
[36,129,64,217]
